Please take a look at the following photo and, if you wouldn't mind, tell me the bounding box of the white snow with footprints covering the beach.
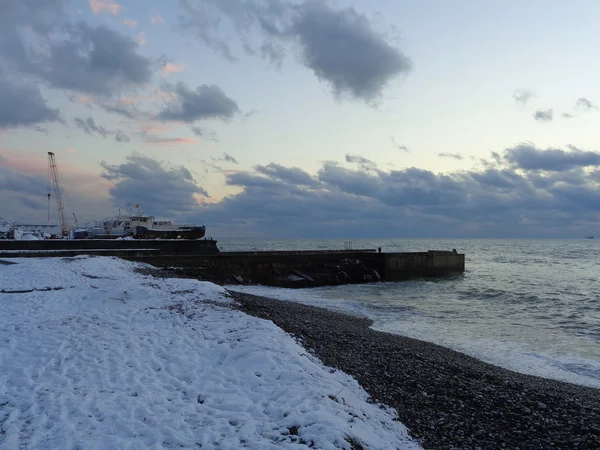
[0,257,420,450]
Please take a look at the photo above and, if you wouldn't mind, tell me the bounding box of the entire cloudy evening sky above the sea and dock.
[0,0,600,239]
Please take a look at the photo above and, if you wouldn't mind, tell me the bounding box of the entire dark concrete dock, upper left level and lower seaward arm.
[0,239,465,287]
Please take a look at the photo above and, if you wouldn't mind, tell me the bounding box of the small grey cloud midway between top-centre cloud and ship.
[158,82,240,123]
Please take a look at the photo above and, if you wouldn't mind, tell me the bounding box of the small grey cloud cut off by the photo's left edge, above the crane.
[0,69,60,128]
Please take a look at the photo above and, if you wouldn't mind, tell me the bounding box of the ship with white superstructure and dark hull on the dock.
[73,205,206,239]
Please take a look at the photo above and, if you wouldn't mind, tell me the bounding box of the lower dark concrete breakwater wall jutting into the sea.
[125,249,465,287]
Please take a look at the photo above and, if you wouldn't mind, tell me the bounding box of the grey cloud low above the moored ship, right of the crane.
[101,153,209,216]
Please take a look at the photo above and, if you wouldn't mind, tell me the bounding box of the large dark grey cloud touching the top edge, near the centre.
[180,0,411,102]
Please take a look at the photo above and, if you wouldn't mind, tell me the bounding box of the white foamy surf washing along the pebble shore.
[227,285,600,388]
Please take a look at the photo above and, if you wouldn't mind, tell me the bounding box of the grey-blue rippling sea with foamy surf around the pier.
[218,239,600,388]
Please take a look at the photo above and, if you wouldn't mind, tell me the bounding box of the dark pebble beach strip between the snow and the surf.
[232,292,600,449]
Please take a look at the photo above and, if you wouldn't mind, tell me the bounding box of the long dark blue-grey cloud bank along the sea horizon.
[180,145,600,238]
